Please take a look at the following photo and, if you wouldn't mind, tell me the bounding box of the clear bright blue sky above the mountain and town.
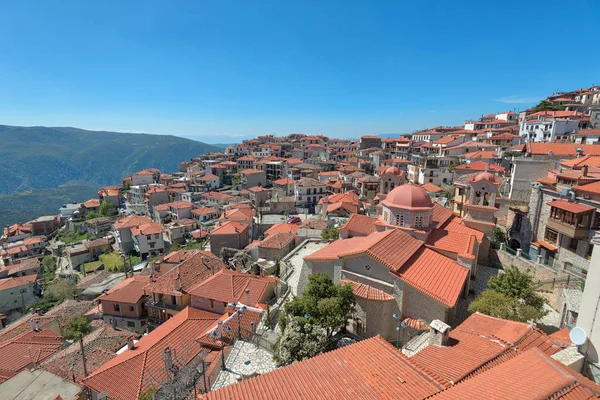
[0,0,600,143]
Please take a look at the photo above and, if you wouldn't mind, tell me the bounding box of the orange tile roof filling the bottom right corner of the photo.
[432,348,600,400]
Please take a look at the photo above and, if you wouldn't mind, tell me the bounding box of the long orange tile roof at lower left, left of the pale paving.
[83,307,220,400]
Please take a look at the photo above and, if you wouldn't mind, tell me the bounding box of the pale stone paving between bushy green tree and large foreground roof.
[212,340,277,390]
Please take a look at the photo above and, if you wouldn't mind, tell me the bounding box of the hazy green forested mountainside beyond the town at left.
[0,125,219,195]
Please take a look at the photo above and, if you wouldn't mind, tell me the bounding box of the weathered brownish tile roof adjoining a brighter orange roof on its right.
[144,250,226,296]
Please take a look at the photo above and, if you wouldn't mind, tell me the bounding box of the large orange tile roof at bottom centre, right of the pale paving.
[200,336,441,400]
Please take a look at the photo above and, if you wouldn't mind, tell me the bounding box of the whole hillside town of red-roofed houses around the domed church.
[0,86,600,400]
